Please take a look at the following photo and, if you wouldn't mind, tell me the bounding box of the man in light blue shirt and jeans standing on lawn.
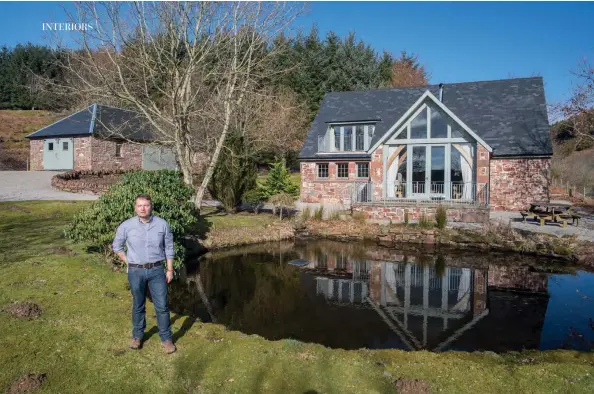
[112,194,176,354]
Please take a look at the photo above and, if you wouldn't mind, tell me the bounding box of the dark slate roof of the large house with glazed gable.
[299,77,553,159]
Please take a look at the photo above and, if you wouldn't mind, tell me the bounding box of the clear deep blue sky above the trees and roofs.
[0,2,594,104]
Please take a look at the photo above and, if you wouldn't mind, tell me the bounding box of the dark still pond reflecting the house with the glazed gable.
[169,241,594,352]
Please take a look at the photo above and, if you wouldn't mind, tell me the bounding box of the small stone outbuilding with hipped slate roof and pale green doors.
[27,104,177,171]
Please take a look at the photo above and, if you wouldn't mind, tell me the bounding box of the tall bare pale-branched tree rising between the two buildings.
[49,2,298,208]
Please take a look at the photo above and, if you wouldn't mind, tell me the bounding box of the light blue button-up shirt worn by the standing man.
[112,216,175,264]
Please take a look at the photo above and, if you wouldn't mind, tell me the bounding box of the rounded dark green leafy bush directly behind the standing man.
[65,170,196,268]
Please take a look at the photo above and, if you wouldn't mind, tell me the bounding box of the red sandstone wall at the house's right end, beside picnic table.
[489,159,551,211]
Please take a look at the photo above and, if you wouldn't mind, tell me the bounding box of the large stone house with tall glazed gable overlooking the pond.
[300,77,553,222]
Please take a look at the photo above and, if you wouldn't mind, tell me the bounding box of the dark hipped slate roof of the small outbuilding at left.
[27,104,153,141]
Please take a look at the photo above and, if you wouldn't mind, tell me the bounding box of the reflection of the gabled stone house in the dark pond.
[307,252,548,350]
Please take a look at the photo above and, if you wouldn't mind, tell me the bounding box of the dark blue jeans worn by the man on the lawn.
[128,266,172,341]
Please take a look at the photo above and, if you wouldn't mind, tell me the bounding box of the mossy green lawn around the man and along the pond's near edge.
[0,202,594,393]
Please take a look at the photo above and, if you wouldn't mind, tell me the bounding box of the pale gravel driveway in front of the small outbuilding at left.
[0,171,98,201]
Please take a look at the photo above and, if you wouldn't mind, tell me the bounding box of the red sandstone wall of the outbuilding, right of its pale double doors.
[89,137,142,171]
